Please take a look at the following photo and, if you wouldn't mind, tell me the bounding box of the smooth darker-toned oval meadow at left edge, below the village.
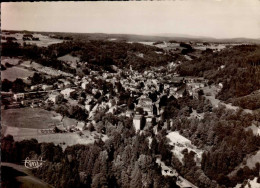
[1,107,61,129]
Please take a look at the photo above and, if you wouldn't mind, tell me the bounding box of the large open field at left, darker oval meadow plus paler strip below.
[2,107,107,149]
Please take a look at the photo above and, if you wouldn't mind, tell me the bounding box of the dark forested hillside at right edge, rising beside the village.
[178,45,260,100]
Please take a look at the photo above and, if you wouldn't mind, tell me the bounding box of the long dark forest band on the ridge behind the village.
[2,41,172,73]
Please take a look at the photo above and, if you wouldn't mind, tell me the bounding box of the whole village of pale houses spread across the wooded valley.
[2,57,211,135]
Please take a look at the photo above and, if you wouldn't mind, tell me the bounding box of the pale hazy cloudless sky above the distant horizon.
[1,0,260,38]
